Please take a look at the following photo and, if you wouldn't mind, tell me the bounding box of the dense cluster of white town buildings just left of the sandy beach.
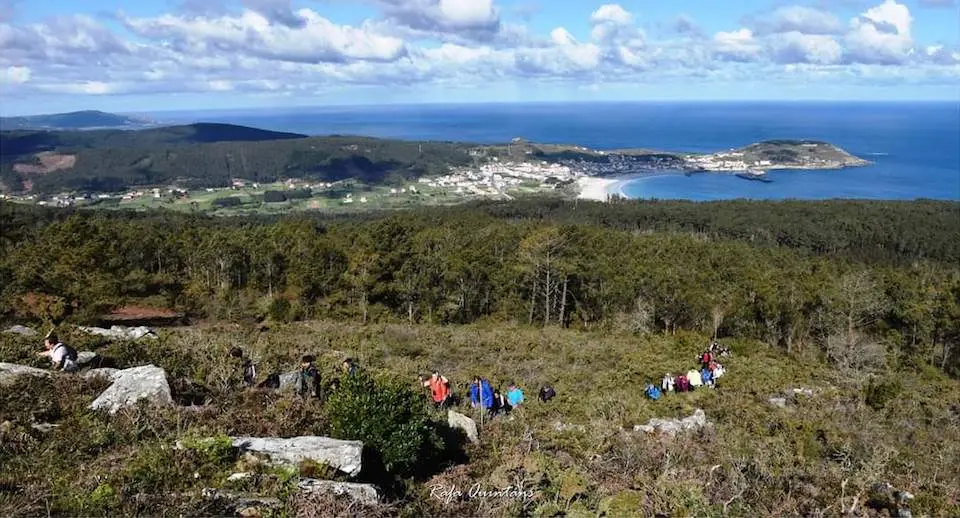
[420,158,582,196]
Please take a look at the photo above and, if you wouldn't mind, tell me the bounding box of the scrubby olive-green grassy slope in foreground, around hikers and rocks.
[0,322,960,516]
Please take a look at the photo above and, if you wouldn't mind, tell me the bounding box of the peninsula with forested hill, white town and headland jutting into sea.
[0,124,868,212]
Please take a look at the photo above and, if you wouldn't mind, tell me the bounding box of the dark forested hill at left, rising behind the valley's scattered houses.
[0,123,470,193]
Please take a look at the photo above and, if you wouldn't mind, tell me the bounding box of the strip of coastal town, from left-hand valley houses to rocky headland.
[0,139,868,208]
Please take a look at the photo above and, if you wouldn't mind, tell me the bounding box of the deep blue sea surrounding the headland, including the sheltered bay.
[150,102,960,200]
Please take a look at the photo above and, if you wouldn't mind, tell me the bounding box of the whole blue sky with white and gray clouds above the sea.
[0,0,960,115]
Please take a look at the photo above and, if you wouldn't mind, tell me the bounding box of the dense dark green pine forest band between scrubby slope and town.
[0,202,960,375]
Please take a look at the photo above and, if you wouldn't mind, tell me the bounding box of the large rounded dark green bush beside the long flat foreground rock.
[327,371,439,476]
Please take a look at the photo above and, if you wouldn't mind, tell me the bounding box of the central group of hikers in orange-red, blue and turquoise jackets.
[418,370,557,418]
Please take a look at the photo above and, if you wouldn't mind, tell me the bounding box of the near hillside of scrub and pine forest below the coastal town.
[0,202,960,518]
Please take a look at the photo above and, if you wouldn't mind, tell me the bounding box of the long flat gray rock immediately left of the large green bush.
[232,436,363,476]
